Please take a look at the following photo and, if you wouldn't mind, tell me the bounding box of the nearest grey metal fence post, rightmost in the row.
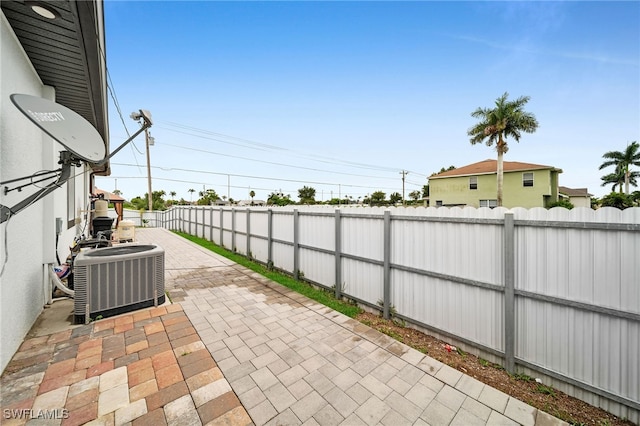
[504,212,516,373]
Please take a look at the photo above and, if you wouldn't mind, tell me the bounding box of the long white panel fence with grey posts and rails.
[154,206,640,422]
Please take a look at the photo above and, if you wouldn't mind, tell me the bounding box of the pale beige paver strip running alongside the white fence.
[139,229,563,425]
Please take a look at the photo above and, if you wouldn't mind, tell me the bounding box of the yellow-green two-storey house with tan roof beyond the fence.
[429,160,562,208]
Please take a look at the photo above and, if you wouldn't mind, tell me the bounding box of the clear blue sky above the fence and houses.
[97,0,640,200]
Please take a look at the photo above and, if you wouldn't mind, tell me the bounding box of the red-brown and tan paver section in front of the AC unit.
[0,304,251,425]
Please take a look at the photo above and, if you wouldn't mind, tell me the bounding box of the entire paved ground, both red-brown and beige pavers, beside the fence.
[0,229,566,426]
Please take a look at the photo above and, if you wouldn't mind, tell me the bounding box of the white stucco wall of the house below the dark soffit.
[0,13,90,371]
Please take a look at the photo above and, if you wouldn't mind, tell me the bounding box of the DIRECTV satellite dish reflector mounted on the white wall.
[11,93,106,163]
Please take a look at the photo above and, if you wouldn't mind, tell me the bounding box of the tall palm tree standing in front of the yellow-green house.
[467,92,538,206]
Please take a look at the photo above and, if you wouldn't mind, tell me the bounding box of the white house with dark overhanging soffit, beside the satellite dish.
[0,0,109,371]
